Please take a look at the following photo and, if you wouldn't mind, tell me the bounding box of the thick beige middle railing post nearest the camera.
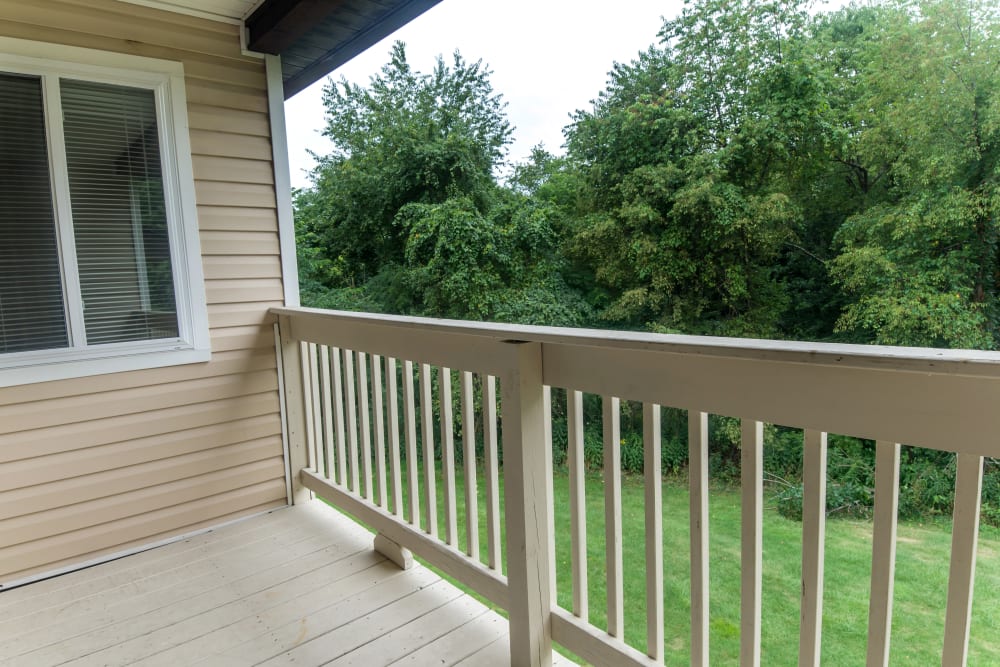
[500,343,554,667]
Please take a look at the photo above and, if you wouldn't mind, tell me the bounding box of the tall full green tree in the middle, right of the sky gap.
[567,0,802,336]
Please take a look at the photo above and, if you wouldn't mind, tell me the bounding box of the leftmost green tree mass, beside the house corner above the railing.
[295,43,589,326]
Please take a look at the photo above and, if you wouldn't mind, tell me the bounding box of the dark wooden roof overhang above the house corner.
[246,0,440,99]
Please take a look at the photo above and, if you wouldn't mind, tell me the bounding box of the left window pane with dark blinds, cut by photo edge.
[0,74,68,353]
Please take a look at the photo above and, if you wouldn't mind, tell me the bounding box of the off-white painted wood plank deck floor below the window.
[0,501,571,667]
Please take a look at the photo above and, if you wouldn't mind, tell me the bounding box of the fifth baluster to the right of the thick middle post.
[740,419,764,667]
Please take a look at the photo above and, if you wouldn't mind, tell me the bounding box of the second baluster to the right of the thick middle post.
[602,396,625,639]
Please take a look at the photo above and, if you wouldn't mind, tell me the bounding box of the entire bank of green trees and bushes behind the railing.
[295,0,1000,521]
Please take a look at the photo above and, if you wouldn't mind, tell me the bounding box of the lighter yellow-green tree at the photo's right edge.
[833,0,1000,348]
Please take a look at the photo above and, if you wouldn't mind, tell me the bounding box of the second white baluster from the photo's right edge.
[866,440,899,667]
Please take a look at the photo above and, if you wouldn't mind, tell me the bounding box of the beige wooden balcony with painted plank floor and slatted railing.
[0,308,1000,665]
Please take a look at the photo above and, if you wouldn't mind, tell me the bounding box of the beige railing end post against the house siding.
[276,315,312,504]
